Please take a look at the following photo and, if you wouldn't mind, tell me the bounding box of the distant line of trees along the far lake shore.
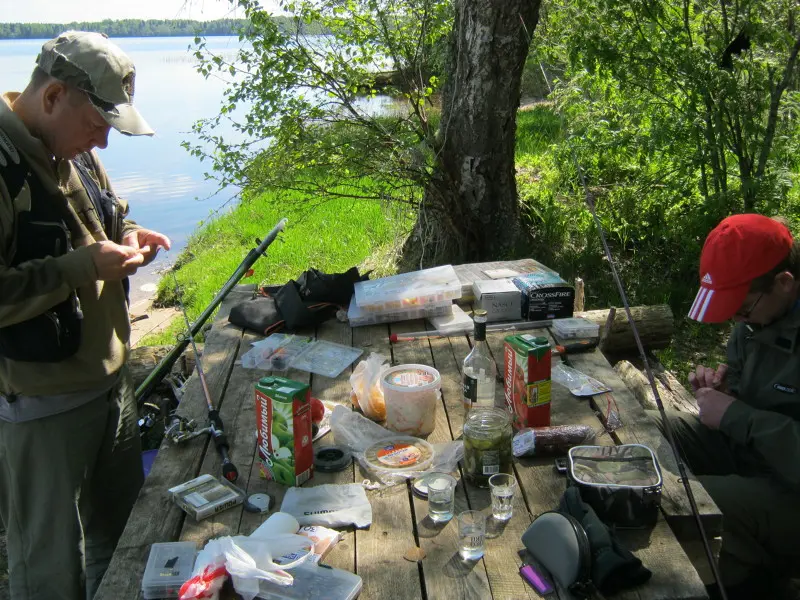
[0,16,326,39]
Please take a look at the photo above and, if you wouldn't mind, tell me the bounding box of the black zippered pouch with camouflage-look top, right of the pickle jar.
[567,444,662,529]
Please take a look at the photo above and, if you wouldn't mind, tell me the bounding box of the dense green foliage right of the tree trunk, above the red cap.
[510,0,800,314]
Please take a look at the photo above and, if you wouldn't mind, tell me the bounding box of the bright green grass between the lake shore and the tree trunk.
[142,181,414,345]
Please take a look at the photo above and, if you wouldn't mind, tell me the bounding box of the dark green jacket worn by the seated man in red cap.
[720,309,800,491]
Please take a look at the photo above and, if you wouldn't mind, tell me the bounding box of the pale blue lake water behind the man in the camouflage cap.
[0,37,240,300]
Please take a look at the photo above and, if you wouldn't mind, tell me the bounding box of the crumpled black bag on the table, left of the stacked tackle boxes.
[228,267,369,335]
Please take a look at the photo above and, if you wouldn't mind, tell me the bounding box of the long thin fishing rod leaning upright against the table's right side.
[570,148,728,600]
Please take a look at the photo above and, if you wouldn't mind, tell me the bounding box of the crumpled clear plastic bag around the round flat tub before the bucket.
[331,405,464,486]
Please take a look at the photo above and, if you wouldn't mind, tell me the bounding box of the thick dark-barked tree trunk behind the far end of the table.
[404,0,540,266]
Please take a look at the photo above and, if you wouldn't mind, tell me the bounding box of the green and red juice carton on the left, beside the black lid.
[255,377,314,486]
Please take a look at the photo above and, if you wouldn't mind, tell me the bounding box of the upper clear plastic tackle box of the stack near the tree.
[355,265,461,312]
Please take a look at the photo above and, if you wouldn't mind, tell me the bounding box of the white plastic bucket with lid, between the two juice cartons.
[381,365,442,435]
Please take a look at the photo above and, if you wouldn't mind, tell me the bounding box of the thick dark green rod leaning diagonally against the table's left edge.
[136,219,287,406]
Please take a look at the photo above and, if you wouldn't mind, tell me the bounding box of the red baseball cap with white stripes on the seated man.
[689,214,793,323]
